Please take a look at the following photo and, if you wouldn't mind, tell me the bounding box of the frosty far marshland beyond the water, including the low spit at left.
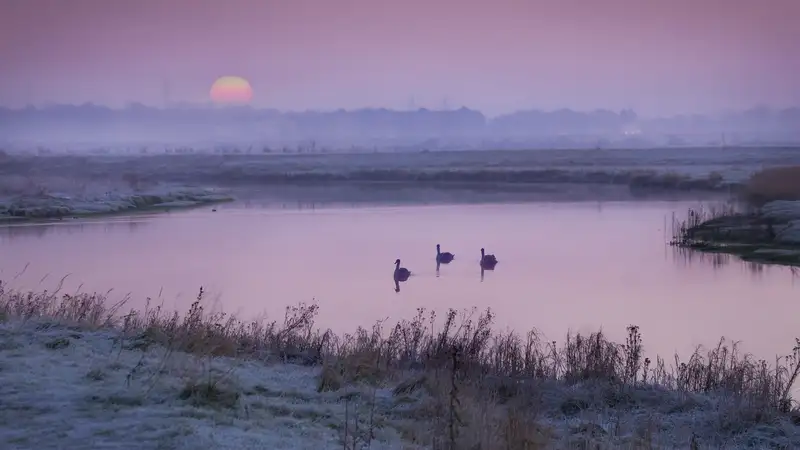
[0,147,800,217]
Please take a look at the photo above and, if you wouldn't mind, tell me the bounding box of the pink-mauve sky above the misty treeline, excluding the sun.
[0,0,800,114]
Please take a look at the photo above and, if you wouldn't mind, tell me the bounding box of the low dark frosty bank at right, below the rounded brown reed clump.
[670,200,800,267]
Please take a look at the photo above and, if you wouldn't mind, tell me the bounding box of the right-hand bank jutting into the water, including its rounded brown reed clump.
[672,166,800,266]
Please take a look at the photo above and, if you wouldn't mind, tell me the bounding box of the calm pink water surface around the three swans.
[0,202,800,358]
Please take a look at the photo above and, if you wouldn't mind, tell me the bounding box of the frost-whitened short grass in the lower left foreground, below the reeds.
[0,320,412,450]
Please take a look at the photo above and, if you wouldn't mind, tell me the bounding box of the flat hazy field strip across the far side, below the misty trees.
[0,147,800,201]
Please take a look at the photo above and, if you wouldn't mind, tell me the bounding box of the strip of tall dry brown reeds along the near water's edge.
[0,282,800,410]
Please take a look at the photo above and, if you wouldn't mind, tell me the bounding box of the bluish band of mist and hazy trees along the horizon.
[0,104,800,149]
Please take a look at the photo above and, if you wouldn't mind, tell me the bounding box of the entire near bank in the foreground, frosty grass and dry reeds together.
[0,285,800,450]
